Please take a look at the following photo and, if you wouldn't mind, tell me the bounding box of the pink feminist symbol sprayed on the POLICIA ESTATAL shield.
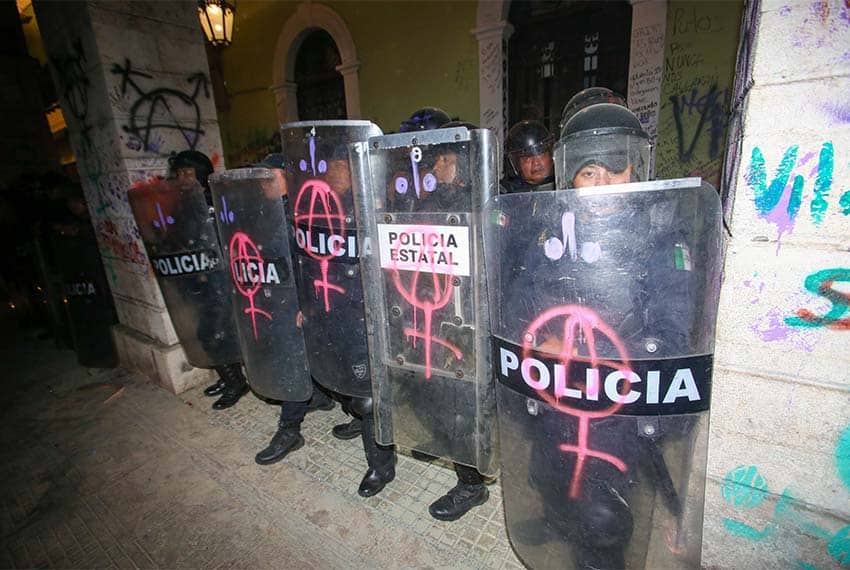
[390,226,463,378]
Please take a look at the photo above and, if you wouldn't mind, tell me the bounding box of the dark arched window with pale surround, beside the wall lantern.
[295,29,346,121]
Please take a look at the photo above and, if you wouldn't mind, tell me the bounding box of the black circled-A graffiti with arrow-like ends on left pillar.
[112,59,210,153]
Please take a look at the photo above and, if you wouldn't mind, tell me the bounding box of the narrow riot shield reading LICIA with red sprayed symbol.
[210,168,313,401]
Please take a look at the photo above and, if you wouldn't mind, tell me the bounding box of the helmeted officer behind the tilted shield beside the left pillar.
[168,150,248,410]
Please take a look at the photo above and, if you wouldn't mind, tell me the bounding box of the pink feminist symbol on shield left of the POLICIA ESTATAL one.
[293,178,345,313]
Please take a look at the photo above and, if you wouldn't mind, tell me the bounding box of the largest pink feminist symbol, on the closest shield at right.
[523,305,631,499]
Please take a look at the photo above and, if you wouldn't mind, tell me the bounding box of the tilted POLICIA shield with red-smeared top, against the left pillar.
[128,175,241,368]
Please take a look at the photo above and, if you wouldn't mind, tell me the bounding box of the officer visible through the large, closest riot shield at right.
[511,103,695,568]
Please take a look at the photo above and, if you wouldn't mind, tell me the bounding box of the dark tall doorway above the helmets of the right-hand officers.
[508,0,632,133]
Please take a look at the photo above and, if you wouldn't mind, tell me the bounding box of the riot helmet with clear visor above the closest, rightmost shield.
[555,103,650,188]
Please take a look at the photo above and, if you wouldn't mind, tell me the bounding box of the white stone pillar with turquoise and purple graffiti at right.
[702,0,850,568]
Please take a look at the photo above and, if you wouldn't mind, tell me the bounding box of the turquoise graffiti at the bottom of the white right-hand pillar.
[720,427,850,569]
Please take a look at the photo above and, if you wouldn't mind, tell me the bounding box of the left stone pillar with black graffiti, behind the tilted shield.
[35,1,222,393]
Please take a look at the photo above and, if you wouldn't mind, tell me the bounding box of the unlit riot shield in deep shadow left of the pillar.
[51,220,118,367]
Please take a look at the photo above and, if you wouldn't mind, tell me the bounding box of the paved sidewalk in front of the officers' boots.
[0,341,522,569]
